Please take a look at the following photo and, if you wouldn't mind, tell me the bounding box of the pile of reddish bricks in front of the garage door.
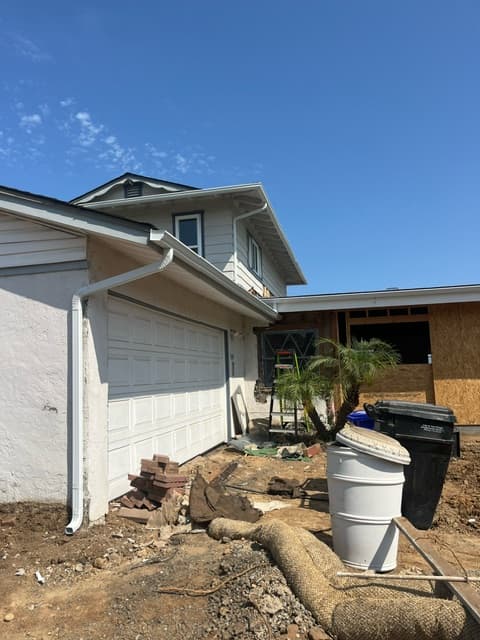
[120,454,188,522]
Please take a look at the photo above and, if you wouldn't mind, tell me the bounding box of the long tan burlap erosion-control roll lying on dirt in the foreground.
[208,518,480,640]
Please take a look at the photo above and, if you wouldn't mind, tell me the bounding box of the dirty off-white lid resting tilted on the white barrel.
[336,424,410,464]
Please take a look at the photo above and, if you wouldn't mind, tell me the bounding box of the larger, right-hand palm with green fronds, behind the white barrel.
[309,338,400,433]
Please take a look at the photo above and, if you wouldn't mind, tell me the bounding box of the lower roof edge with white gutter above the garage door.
[0,186,277,322]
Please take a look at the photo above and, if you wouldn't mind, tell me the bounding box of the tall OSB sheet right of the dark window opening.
[430,302,480,424]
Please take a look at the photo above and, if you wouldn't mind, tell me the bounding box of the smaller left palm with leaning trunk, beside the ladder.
[275,367,332,440]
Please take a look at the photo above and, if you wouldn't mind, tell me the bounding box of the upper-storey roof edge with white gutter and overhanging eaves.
[72,174,307,285]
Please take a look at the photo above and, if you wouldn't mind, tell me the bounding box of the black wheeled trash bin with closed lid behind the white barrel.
[364,400,456,529]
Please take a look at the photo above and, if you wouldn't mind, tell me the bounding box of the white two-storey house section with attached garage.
[0,174,305,533]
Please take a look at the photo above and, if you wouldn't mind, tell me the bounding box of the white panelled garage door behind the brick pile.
[108,297,227,499]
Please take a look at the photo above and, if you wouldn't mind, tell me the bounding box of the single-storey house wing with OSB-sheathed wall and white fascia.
[259,285,480,425]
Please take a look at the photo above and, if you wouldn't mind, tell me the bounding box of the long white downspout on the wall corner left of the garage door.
[65,249,173,535]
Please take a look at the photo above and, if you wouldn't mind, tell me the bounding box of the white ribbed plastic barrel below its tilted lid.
[327,443,404,571]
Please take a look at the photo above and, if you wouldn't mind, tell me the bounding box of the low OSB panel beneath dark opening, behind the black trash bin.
[360,364,435,407]
